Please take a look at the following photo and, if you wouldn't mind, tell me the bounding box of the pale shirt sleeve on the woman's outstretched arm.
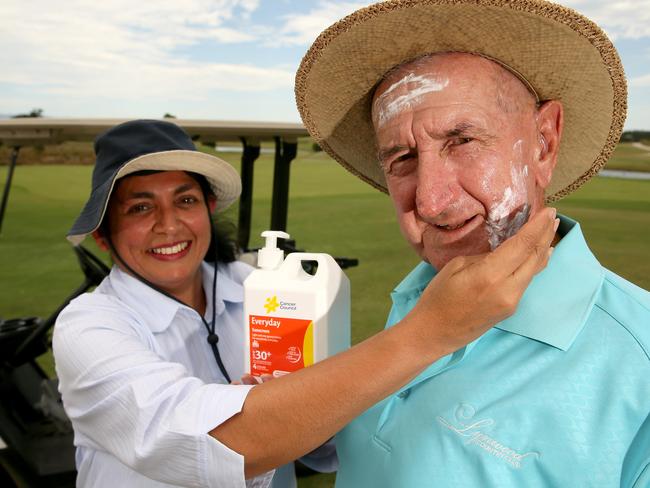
[53,294,251,487]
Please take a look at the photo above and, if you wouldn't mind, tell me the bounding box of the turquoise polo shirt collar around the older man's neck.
[391,216,604,351]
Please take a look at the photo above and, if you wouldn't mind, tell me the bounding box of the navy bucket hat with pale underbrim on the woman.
[67,120,241,245]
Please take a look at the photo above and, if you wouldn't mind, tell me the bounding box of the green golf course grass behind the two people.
[0,142,650,488]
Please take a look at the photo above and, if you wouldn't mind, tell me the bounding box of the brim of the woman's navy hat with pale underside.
[67,150,241,246]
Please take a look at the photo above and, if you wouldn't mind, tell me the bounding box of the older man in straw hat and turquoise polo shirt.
[296,0,650,487]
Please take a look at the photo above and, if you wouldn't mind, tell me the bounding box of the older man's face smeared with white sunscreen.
[372,53,561,269]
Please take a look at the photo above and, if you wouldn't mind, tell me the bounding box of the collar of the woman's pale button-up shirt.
[109,262,244,333]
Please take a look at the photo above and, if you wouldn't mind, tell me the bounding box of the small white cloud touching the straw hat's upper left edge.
[269,0,369,46]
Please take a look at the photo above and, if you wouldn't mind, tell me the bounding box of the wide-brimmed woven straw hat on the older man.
[296,0,627,202]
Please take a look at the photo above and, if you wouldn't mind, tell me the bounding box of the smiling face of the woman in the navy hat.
[93,171,216,298]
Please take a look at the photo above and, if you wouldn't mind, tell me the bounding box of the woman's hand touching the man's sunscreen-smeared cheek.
[402,208,559,353]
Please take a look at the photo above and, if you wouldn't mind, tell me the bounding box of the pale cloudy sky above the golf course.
[0,0,650,130]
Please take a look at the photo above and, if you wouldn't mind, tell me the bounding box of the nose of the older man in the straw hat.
[415,152,460,219]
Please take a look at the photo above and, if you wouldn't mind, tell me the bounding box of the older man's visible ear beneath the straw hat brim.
[535,100,564,189]
